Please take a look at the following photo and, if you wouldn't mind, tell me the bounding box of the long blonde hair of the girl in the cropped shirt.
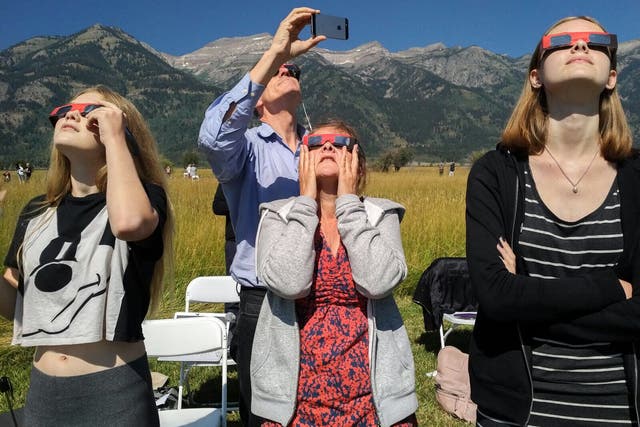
[45,85,175,312]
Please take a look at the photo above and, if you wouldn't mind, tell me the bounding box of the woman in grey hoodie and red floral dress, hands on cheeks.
[251,121,418,427]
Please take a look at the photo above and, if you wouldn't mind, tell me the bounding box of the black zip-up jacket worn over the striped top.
[466,145,640,425]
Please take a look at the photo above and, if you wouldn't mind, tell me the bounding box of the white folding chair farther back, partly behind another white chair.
[175,276,240,411]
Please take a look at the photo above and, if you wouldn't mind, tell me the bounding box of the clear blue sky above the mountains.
[0,0,640,57]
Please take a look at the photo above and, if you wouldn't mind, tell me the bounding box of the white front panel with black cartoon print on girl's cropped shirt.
[22,207,115,338]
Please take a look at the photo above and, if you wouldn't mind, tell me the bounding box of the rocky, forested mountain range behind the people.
[0,24,640,167]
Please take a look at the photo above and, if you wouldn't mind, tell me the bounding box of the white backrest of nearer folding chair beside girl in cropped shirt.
[142,317,226,357]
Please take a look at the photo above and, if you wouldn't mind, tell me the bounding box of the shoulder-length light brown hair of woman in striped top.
[502,16,633,162]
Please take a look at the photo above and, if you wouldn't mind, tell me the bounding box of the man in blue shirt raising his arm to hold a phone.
[198,7,325,426]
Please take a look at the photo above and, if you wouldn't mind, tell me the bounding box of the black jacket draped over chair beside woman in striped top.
[413,257,478,331]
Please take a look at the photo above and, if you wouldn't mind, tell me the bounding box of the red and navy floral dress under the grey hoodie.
[262,231,417,427]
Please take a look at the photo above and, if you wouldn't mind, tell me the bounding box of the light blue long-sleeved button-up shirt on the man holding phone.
[198,74,305,286]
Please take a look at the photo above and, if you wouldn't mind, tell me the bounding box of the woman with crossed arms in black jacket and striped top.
[467,17,640,427]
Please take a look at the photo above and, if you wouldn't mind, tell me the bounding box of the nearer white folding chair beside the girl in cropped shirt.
[142,317,227,427]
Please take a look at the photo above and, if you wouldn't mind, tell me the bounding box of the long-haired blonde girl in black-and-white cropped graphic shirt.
[0,86,173,426]
